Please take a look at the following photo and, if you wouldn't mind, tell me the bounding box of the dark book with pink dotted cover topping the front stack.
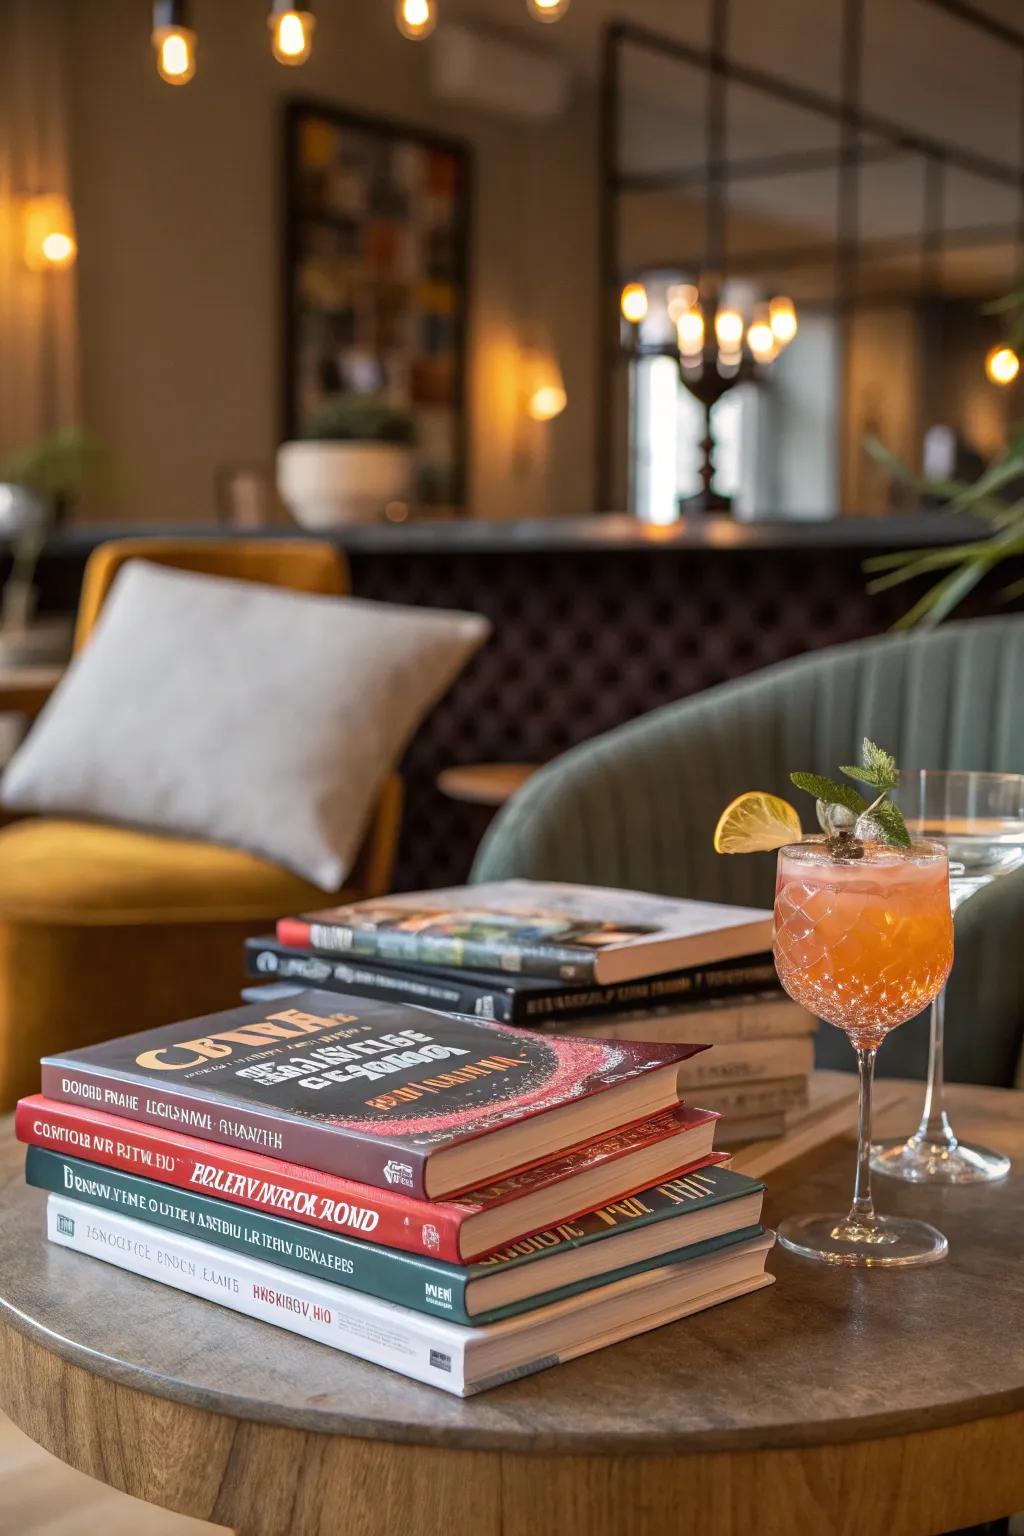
[43,992,705,1200]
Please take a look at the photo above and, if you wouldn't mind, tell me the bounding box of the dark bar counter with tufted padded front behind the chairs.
[11,513,1019,889]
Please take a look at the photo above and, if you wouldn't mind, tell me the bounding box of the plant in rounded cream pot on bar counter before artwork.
[278,395,413,528]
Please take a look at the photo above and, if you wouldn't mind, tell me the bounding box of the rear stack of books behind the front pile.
[247,880,817,1147]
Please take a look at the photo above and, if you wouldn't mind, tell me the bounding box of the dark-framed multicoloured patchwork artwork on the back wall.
[284,101,470,508]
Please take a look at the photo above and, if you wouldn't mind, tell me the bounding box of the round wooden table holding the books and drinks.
[0,1089,1024,1536]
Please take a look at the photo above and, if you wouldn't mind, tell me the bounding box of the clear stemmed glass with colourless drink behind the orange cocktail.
[870,768,1024,1184]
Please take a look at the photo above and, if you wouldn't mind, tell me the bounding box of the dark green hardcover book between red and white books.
[25,1146,763,1324]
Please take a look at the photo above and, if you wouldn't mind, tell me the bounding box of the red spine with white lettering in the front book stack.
[14,1101,462,1264]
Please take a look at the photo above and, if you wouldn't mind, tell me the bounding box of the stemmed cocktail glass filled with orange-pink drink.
[774,837,953,1266]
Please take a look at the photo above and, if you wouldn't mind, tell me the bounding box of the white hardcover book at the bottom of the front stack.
[46,1195,774,1398]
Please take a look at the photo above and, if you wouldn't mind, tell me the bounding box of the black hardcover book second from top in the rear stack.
[246,935,778,1025]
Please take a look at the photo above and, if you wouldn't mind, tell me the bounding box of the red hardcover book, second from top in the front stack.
[15,1094,717,1264]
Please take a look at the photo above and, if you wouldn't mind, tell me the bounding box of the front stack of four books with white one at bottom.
[15,991,772,1396]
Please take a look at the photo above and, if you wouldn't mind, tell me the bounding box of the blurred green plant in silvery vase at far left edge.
[0,427,111,667]
